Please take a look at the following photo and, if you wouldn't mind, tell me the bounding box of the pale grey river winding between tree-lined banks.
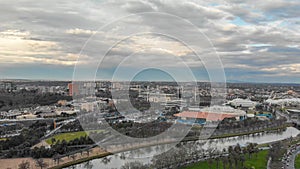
[68,127,300,169]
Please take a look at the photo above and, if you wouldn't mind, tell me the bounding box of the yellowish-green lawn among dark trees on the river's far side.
[46,130,103,144]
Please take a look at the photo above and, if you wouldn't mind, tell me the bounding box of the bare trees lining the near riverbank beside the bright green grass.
[121,143,259,169]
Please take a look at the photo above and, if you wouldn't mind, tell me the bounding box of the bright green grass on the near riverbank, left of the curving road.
[184,150,268,169]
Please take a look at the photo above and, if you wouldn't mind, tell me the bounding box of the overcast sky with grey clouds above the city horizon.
[0,0,300,83]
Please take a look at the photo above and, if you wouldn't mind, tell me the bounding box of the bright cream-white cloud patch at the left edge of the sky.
[0,30,88,66]
